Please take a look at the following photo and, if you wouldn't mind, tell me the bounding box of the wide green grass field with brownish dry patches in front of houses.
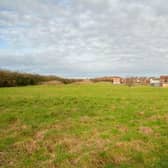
[0,83,168,168]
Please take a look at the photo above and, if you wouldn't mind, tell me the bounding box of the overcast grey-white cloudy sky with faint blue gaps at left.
[0,0,168,77]
